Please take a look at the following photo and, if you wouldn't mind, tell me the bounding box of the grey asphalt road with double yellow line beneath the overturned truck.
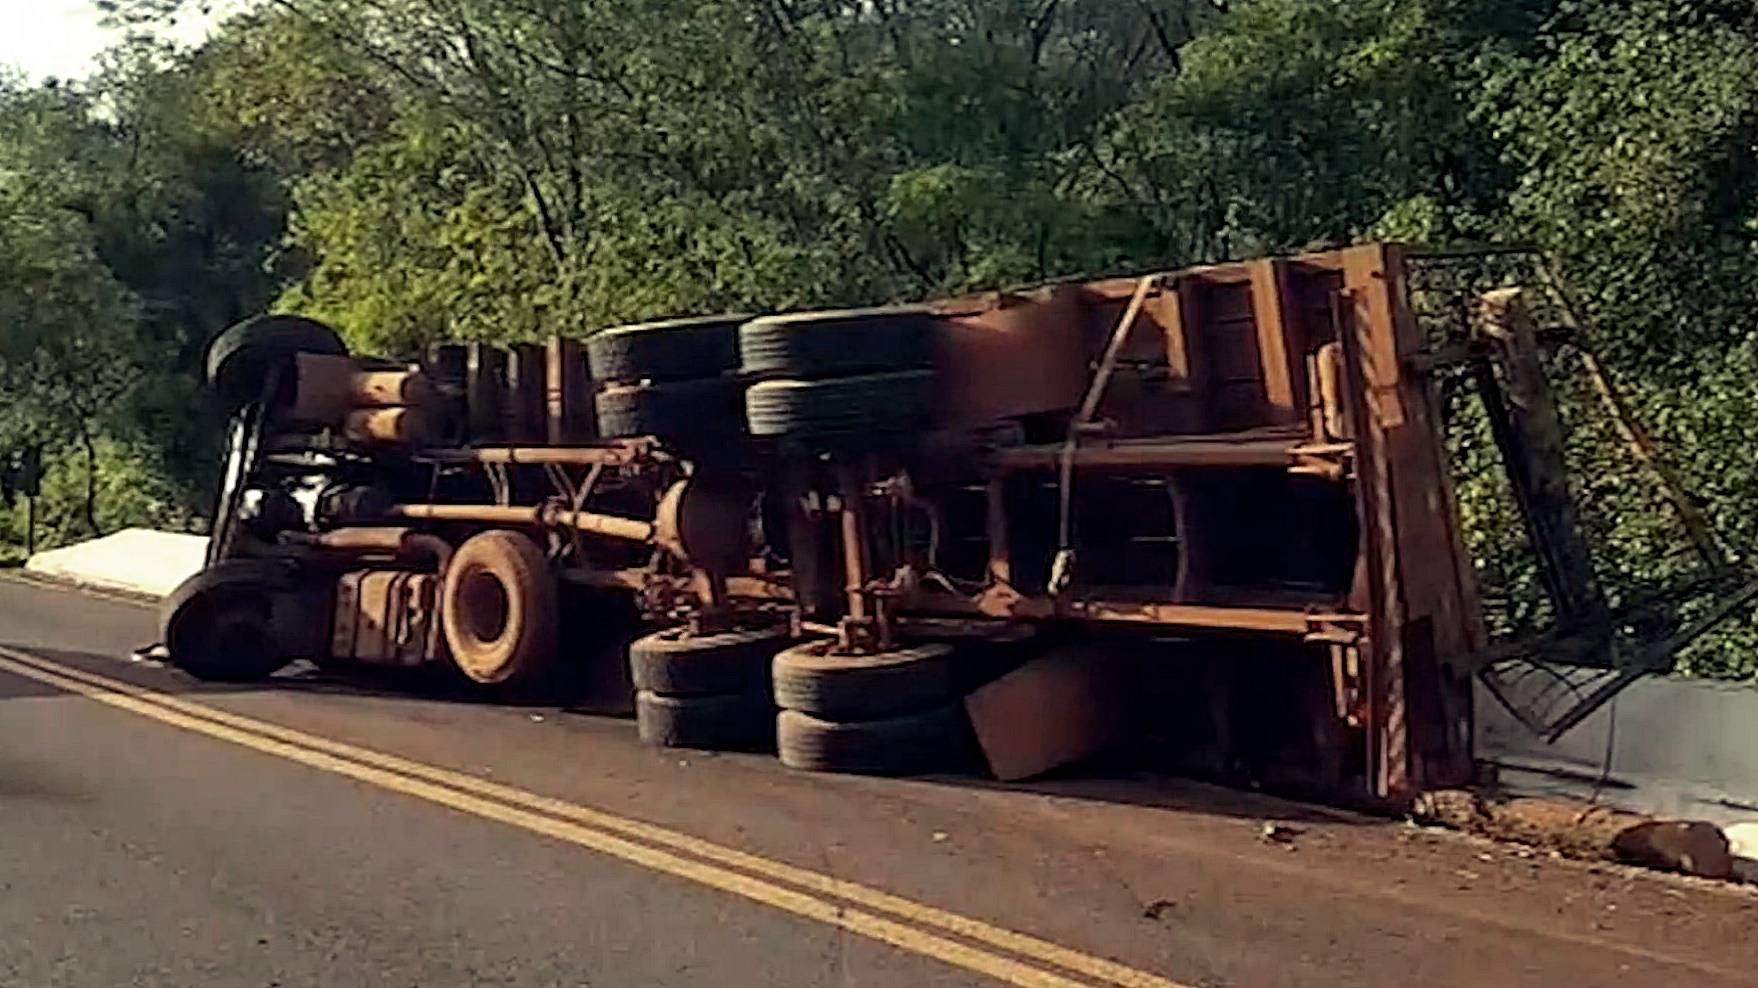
[0,569,1758,988]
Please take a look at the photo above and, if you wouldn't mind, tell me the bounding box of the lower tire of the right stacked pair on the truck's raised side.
[745,371,933,445]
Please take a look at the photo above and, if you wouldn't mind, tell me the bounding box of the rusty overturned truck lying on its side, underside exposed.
[163,244,1554,800]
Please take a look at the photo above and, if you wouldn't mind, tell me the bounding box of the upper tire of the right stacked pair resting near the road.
[772,642,960,721]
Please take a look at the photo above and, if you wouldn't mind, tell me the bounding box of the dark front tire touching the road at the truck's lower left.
[160,559,292,682]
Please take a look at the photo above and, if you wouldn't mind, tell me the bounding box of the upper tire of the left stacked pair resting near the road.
[629,628,788,696]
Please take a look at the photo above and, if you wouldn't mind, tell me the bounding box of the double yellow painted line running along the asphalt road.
[0,647,1188,988]
